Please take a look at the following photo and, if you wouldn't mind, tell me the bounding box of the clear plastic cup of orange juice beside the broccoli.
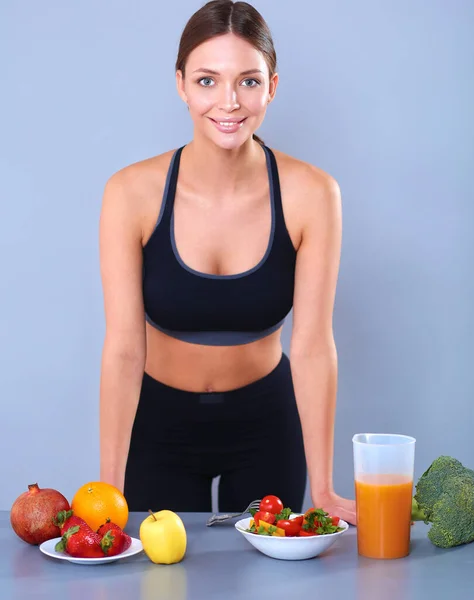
[352,433,416,558]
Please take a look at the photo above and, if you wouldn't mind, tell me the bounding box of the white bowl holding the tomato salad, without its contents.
[235,514,349,560]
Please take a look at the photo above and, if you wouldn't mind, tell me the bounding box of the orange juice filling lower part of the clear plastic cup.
[355,474,413,558]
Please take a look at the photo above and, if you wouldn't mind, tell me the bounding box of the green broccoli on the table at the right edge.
[412,456,474,548]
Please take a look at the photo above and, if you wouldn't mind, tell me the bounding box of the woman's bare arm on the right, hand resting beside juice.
[290,166,356,523]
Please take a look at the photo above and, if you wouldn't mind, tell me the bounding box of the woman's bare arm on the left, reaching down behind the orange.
[100,171,146,491]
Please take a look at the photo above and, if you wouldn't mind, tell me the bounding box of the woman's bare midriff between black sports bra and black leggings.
[145,323,282,393]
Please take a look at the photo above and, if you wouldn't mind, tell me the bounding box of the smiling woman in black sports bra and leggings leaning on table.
[100,0,355,523]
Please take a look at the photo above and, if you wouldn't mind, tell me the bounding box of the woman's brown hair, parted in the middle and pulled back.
[175,0,276,145]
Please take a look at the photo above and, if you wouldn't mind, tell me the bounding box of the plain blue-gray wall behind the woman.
[0,0,474,509]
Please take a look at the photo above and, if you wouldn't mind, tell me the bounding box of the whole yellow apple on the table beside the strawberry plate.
[140,510,187,565]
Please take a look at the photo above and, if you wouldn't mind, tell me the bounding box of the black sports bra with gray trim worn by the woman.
[143,146,296,346]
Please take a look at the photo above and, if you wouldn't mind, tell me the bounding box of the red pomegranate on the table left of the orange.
[10,483,71,545]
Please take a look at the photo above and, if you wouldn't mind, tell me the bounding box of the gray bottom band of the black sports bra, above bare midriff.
[145,313,285,346]
